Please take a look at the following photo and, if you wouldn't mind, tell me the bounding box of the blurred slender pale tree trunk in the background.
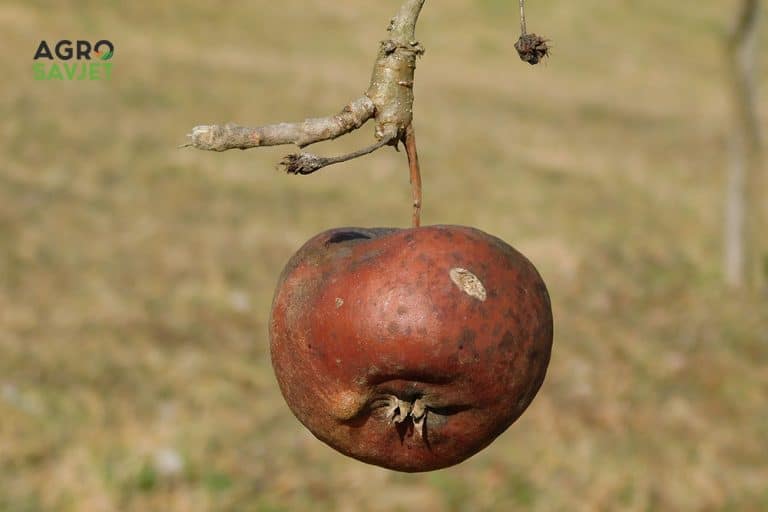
[725,0,768,289]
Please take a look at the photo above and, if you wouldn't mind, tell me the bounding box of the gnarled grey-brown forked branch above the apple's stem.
[182,0,425,174]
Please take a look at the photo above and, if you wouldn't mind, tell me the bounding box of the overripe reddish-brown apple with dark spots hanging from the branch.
[270,226,552,472]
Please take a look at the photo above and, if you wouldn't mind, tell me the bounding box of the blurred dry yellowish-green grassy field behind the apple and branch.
[0,0,768,512]
